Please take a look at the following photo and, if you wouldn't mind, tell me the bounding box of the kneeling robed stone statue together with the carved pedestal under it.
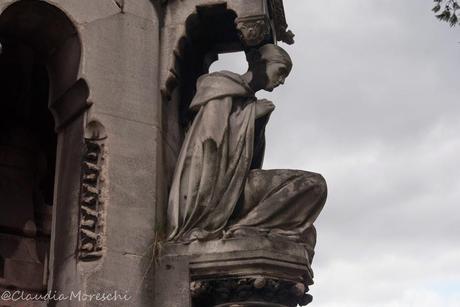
[160,44,327,307]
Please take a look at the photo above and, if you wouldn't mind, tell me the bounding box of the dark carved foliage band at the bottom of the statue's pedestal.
[190,277,312,307]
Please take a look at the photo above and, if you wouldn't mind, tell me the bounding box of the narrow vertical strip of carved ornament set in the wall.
[79,121,106,261]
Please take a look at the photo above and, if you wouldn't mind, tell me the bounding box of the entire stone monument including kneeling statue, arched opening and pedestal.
[0,0,326,307]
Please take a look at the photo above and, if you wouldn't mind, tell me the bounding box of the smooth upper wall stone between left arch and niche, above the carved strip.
[81,14,160,125]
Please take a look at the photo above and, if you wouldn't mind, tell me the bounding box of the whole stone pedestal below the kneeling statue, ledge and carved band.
[160,237,313,307]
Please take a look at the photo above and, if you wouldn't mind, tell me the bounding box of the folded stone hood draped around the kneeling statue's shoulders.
[190,71,254,111]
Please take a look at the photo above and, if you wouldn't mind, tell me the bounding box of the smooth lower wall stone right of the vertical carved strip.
[61,113,159,306]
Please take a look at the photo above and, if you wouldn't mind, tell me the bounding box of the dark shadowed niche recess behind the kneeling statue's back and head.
[156,3,243,238]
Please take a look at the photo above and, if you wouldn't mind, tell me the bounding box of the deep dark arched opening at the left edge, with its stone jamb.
[0,0,89,293]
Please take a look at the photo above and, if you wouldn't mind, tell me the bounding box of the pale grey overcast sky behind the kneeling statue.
[213,0,460,307]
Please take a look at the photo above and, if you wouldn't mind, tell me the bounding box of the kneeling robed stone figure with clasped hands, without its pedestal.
[168,44,327,259]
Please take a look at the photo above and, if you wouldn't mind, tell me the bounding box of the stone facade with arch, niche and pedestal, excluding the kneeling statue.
[0,0,324,307]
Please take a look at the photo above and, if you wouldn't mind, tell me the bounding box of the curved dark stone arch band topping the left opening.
[0,0,90,129]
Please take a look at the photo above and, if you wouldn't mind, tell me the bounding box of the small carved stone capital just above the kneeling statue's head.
[235,15,271,47]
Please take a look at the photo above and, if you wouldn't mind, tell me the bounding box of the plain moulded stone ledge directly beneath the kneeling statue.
[162,236,313,285]
